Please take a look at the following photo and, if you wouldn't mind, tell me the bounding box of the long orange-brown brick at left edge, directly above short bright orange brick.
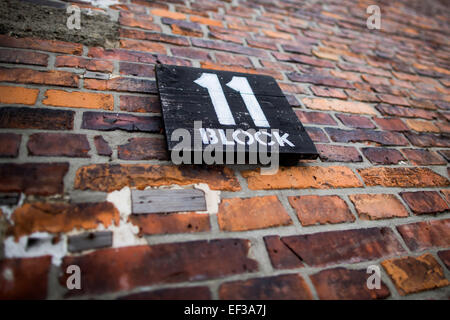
[0,68,79,88]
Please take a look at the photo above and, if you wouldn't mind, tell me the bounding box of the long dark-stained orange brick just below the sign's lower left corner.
[75,164,241,192]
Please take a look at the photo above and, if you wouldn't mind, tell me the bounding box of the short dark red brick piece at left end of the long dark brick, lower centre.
[264,236,304,269]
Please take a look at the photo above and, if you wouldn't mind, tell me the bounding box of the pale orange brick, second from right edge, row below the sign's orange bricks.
[349,194,408,220]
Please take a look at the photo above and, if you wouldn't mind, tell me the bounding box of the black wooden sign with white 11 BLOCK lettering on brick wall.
[156,64,318,164]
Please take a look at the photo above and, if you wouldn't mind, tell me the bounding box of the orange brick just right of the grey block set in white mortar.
[217,196,292,231]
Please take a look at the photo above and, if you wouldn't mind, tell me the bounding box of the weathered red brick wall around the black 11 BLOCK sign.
[0,0,450,299]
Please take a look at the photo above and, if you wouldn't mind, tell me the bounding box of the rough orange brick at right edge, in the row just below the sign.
[358,167,450,188]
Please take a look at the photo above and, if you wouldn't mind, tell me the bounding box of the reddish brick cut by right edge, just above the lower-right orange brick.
[397,219,450,251]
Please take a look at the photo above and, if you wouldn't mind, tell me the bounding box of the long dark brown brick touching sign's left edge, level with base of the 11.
[81,112,162,133]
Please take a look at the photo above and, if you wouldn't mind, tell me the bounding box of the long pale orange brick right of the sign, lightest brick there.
[302,98,376,115]
